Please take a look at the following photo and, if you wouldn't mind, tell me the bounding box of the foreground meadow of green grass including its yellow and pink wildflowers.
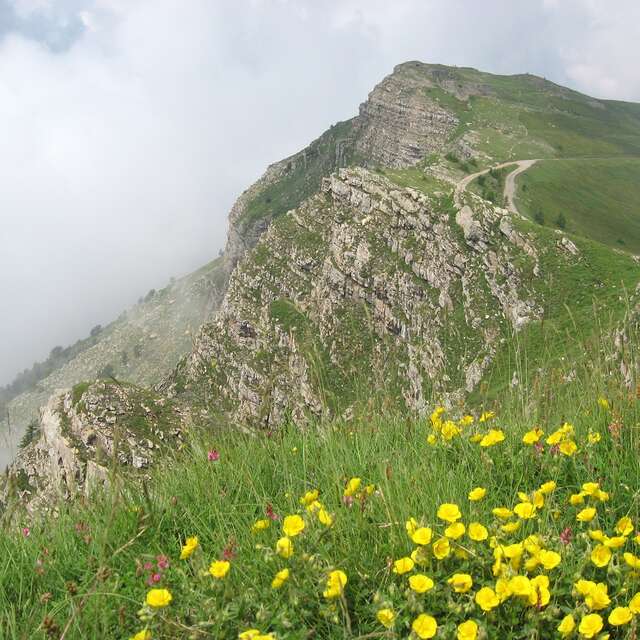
[0,312,640,640]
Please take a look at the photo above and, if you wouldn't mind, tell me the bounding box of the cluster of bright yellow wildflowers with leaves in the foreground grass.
[121,405,640,640]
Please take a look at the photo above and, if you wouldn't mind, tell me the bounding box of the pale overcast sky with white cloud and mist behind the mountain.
[0,0,640,384]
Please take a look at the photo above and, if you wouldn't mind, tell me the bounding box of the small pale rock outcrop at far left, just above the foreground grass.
[0,382,186,513]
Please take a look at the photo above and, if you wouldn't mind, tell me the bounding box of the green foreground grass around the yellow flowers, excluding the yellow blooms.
[0,379,640,640]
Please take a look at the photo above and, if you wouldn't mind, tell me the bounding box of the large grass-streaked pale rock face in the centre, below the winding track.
[172,168,542,426]
